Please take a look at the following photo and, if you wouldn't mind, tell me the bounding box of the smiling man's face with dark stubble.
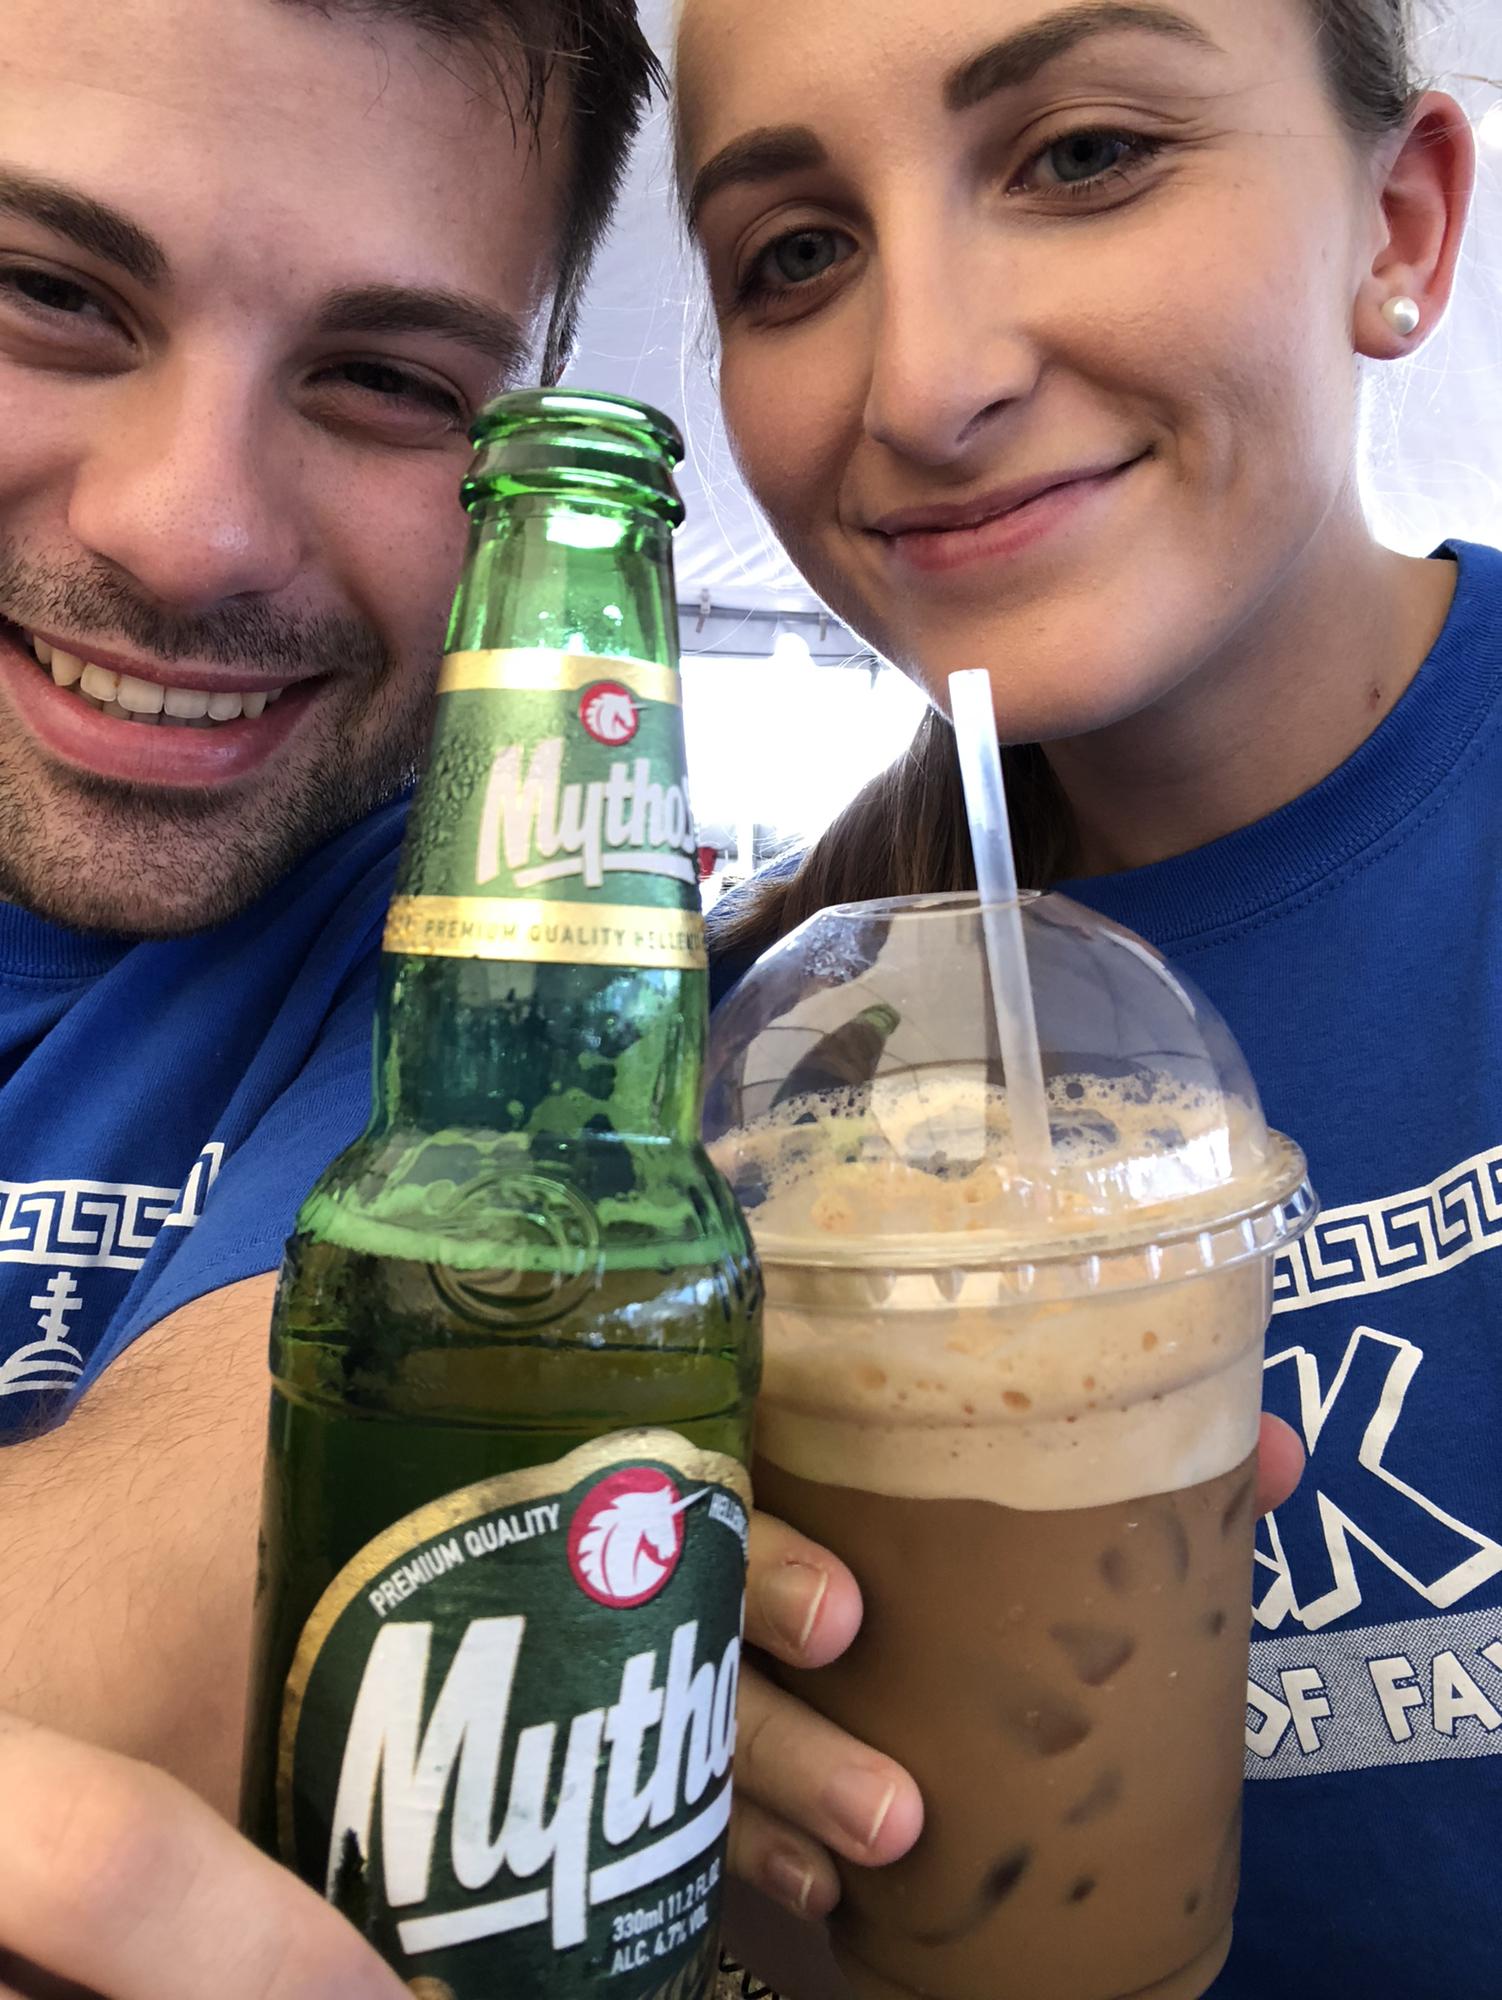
[0,0,566,934]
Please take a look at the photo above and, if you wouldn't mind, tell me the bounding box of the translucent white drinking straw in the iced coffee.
[950,668,1054,1186]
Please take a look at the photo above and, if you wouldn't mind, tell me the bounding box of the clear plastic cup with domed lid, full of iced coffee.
[706,896,1314,2000]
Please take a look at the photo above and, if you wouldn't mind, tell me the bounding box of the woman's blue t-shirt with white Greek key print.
[718,548,1502,2000]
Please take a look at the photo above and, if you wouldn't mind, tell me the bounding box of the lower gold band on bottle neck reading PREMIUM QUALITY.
[384,896,708,972]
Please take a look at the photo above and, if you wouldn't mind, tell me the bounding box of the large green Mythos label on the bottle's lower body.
[278,1430,750,2000]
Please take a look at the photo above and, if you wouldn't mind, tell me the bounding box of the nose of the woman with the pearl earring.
[864,234,1042,466]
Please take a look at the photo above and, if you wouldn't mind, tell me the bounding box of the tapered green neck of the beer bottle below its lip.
[376,494,708,1146]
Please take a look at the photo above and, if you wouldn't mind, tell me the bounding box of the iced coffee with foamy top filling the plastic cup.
[728,1086,1292,2000]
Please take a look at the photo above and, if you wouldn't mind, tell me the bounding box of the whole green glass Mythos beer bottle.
[244,392,760,2000]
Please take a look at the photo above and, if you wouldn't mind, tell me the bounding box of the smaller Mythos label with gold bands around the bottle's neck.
[386,650,704,968]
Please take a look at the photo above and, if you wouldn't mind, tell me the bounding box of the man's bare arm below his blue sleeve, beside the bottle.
[0,1274,276,1814]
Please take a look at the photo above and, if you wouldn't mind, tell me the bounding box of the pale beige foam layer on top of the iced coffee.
[732,1076,1272,1510]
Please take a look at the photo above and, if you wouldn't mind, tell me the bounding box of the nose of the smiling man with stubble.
[68,358,304,614]
